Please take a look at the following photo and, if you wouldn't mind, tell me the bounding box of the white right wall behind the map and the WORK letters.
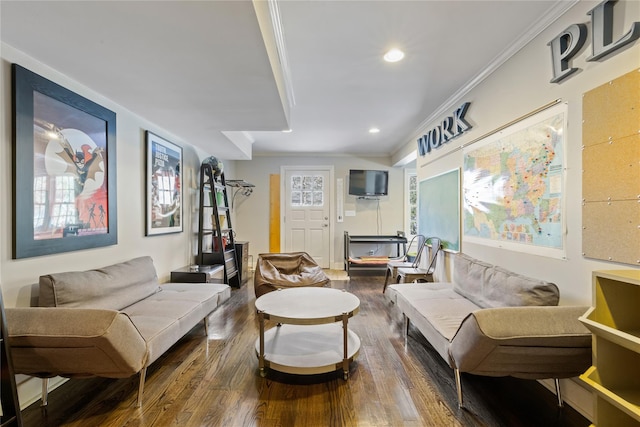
[407,1,640,417]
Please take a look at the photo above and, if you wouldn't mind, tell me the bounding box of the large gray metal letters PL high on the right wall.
[548,0,640,83]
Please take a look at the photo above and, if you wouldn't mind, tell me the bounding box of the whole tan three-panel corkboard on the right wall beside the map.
[582,69,640,266]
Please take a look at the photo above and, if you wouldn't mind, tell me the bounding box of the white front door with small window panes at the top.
[280,166,333,268]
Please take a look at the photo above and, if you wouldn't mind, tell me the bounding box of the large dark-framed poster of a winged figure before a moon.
[12,64,118,259]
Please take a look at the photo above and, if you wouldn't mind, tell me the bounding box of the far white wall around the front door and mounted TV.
[234,156,405,269]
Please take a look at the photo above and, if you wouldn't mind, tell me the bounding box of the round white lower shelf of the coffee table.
[255,323,360,380]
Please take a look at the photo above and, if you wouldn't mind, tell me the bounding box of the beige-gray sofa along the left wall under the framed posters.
[6,257,231,406]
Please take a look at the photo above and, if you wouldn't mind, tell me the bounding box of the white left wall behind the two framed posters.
[0,44,234,407]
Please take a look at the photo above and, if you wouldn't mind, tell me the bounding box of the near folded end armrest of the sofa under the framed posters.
[5,307,147,378]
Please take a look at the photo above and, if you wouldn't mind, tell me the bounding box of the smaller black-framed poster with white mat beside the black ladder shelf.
[146,131,182,236]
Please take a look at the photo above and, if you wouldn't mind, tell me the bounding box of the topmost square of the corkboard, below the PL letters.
[582,69,640,146]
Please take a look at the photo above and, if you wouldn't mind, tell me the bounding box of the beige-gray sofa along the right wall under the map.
[386,254,591,407]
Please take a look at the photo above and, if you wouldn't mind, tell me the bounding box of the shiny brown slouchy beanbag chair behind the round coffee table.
[253,252,331,297]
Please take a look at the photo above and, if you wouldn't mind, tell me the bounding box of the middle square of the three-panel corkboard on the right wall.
[582,134,640,202]
